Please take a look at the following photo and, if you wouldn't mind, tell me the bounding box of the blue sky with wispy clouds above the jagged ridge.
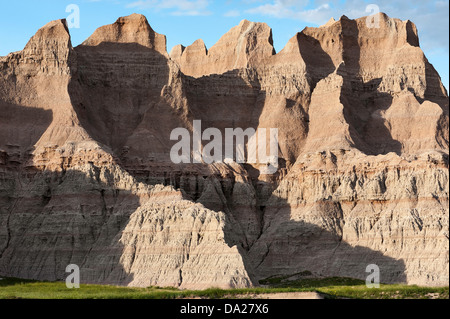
[0,0,449,90]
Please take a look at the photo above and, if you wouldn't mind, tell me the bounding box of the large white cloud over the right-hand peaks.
[246,0,449,54]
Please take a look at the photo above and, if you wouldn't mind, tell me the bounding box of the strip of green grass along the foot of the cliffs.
[0,274,449,299]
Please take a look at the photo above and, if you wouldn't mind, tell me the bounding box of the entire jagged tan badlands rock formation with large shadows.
[0,14,449,288]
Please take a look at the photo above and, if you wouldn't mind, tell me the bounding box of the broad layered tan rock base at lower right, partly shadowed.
[249,151,449,286]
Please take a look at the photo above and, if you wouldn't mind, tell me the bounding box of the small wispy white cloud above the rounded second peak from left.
[127,0,212,16]
